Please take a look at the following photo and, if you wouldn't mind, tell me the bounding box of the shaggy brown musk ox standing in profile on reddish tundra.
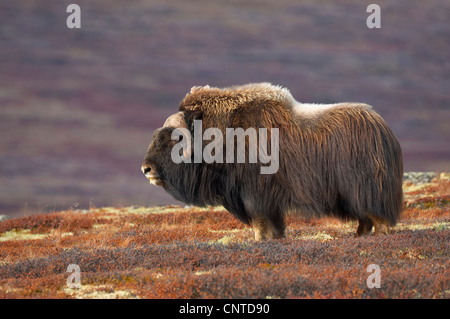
[141,83,403,240]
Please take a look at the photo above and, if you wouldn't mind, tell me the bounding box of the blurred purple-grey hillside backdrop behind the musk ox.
[0,0,450,216]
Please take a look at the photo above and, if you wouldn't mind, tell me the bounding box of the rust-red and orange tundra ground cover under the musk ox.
[0,174,450,298]
